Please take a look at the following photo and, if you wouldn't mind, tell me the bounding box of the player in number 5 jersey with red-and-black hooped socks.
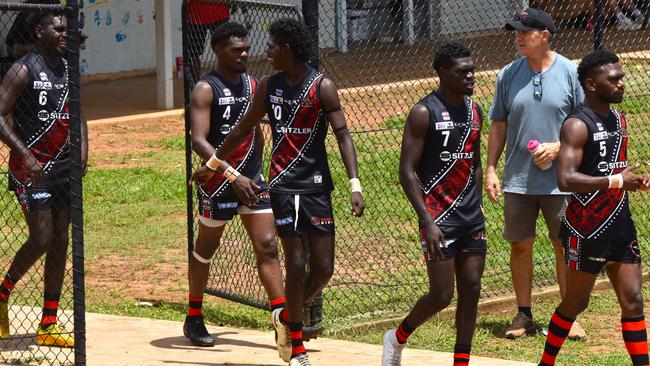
[539,50,650,366]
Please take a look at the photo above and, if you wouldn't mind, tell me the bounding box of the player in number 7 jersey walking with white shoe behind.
[382,42,486,366]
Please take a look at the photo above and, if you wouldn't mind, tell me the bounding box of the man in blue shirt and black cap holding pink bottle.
[485,8,584,339]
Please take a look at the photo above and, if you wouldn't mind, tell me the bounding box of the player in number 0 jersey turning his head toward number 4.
[193,19,364,366]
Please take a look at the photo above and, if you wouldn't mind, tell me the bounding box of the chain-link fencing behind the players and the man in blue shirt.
[181,0,650,325]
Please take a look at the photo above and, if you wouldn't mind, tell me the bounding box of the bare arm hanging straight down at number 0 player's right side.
[320,78,365,216]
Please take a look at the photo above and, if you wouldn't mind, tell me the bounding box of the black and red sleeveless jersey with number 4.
[199,71,266,197]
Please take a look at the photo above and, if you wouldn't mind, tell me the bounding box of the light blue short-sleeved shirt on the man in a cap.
[490,53,584,195]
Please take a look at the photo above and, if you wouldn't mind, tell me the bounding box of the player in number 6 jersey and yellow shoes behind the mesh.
[0,11,88,347]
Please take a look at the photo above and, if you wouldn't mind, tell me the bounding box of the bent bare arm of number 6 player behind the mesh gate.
[0,64,44,184]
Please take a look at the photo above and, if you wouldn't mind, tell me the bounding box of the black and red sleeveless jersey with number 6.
[9,50,70,189]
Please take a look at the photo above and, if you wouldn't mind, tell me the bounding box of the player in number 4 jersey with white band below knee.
[183,22,290,353]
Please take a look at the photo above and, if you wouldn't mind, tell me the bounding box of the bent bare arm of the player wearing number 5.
[557,118,646,193]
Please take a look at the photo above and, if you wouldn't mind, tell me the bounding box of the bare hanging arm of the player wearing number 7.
[399,105,444,259]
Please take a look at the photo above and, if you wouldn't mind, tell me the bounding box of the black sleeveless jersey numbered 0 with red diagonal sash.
[266,69,334,194]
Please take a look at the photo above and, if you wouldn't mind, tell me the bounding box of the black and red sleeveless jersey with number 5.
[561,105,636,240]
